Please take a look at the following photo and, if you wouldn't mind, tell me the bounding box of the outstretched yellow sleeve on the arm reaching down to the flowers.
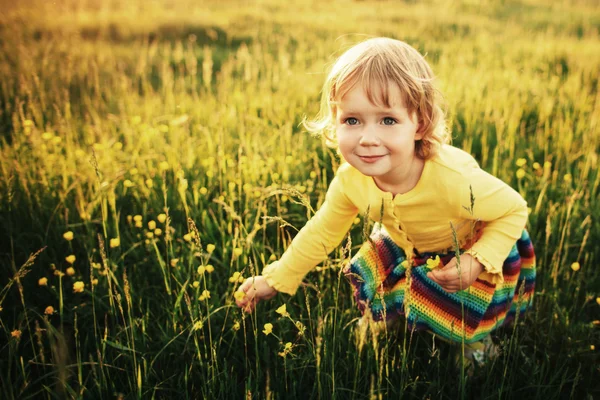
[262,167,358,295]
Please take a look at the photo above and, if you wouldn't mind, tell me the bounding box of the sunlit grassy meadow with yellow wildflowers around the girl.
[0,0,600,399]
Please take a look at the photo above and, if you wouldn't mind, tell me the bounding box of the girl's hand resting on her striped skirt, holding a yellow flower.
[427,254,485,293]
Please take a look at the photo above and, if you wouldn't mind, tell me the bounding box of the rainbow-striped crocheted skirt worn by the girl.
[343,226,535,343]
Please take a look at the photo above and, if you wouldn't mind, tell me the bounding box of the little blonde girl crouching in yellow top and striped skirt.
[237,38,535,366]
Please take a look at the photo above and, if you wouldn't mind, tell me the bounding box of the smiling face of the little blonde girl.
[336,83,422,187]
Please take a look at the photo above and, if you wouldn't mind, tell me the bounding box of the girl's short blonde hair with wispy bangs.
[304,38,450,159]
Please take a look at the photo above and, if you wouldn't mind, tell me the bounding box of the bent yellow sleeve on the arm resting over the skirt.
[459,165,527,283]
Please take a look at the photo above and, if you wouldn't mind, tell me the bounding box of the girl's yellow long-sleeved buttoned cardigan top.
[262,145,527,295]
